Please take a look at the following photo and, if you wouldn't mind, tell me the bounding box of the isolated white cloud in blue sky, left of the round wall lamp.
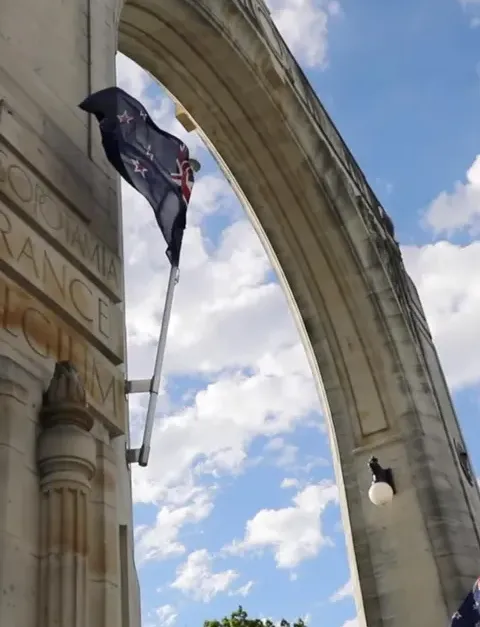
[225,481,338,568]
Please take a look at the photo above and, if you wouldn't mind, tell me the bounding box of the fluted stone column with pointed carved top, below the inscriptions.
[38,362,96,627]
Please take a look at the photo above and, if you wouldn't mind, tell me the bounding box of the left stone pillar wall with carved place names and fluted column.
[0,0,140,627]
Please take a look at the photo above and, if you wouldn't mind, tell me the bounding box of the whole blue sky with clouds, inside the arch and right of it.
[117,0,480,627]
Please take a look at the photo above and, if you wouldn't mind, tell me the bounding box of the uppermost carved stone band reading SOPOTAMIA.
[0,146,122,302]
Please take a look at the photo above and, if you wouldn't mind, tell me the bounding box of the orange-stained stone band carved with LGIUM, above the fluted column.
[0,273,126,435]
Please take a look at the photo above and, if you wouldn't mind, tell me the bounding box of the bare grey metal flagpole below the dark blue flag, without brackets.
[138,266,179,466]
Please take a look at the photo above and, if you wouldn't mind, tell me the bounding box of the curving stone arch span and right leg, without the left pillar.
[119,0,479,626]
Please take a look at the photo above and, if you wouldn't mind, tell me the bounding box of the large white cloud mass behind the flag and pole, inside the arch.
[117,55,318,561]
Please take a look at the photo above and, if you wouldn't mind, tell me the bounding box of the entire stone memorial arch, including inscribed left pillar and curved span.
[0,0,480,627]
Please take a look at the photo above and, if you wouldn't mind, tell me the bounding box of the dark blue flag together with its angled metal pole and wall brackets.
[78,86,200,466]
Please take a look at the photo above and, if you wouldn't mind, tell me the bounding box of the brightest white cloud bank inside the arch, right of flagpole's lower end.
[133,346,317,502]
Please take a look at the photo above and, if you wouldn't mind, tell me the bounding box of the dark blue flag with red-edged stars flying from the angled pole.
[79,87,194,266]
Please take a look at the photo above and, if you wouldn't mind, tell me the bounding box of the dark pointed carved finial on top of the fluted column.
[40,361,94,431]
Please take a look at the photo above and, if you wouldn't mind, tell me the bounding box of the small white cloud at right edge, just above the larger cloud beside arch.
[425,155,480,236]
